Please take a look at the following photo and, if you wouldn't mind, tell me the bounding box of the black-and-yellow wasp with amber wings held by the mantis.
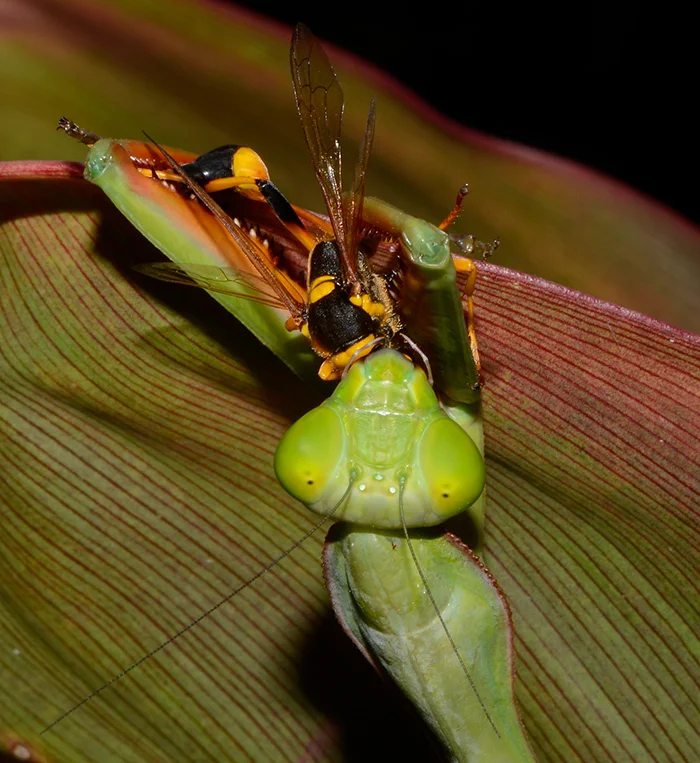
[59,24,500,386]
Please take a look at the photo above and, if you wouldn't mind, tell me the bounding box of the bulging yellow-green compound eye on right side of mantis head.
[418,417,486,519]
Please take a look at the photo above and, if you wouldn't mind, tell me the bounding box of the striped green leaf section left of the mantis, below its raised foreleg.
[0,170,334,761]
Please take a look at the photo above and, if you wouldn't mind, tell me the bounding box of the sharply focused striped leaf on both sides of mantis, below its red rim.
[0,165,700,761]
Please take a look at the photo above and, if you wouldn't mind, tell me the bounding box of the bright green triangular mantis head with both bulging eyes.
[275,349,484,528]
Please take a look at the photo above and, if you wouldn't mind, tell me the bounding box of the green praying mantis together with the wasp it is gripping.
[48,26,534,761]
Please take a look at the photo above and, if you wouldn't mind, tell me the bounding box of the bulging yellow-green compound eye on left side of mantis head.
[275,406,345,505]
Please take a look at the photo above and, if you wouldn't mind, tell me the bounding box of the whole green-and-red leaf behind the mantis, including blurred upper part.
[0,0,700,762]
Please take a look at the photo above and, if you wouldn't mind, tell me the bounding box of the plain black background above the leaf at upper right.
[234,0,700,223]
